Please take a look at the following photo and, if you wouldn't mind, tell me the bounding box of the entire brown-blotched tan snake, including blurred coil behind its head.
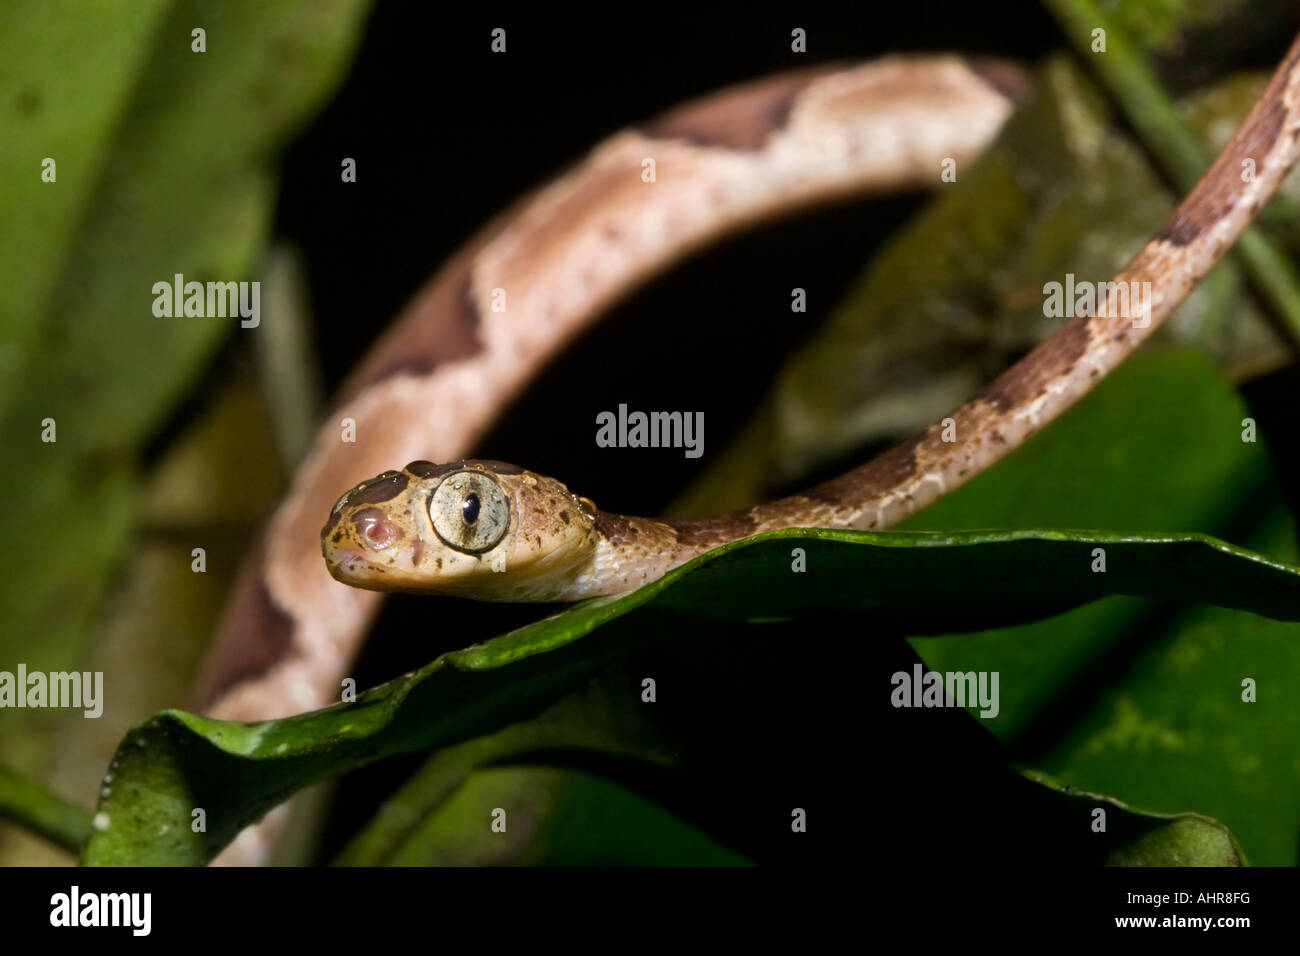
[191,40,1300,862]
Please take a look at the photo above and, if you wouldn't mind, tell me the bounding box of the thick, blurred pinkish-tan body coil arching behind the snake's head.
[194,56,1024,721]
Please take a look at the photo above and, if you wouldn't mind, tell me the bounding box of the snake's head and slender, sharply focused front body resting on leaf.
[321,40,1300,601]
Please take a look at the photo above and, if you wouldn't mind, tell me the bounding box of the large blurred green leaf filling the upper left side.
[0,0,368,790]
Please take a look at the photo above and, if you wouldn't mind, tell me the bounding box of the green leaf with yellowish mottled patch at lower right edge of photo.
[1040,515,1300,866]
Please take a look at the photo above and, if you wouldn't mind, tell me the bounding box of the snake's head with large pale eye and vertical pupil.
[321,459,595,601]
